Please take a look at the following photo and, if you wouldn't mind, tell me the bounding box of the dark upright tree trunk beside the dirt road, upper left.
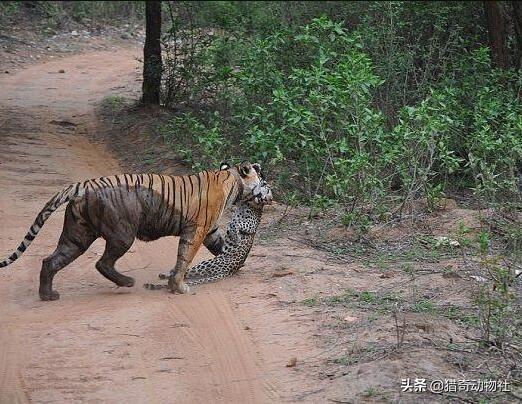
[141,1,162,105]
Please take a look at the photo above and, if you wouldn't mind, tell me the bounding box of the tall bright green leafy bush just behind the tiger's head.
[237,18,384,208]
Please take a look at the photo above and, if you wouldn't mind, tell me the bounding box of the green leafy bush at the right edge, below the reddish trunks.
[387,47,522,207]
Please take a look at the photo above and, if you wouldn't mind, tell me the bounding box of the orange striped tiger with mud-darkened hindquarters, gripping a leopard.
[0,162,261,301]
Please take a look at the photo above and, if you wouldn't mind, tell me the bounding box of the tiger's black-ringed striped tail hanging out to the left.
[0,182,85,268]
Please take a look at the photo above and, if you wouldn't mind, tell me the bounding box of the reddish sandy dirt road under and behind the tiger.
[0,50,300,403]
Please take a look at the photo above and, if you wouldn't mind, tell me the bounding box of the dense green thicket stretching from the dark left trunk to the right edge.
[152,2,522,224]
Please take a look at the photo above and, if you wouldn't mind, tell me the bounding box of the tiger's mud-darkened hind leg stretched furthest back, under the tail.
[39,204,97,301]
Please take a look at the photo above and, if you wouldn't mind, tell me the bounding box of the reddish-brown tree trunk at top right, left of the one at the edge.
[484,1,508,69]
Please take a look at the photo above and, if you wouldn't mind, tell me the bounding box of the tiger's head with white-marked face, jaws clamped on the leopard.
[220,162,272,205]
